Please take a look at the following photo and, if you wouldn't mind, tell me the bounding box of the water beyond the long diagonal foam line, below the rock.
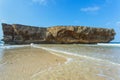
[37,43,120,65]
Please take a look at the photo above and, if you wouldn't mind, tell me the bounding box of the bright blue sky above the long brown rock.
[0,0,120,41]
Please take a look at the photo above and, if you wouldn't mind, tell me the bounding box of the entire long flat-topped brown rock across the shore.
[2,23,115,44]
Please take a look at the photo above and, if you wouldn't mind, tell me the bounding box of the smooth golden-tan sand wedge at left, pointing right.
[0,47,66,80]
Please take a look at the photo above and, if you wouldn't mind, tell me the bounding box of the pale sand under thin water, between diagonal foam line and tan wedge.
[33,50,120,80]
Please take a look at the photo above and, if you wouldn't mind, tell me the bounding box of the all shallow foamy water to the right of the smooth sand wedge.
[33,44,120,80]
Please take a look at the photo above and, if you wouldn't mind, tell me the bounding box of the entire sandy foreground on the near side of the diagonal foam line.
[0,47,120,80]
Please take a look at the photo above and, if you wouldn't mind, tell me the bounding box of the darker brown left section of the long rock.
[2,23,46,44]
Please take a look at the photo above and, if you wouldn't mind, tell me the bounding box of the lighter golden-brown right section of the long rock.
[47,26,115,43]
